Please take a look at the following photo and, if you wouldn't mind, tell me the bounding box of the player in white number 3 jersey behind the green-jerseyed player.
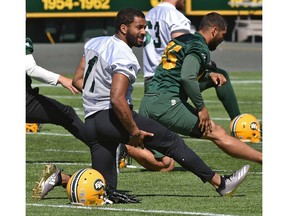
[143,0,240,120]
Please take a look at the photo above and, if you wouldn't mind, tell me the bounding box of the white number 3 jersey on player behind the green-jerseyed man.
[143,2,195,77]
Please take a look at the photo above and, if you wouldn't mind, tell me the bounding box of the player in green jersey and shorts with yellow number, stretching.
[139,12,262,164]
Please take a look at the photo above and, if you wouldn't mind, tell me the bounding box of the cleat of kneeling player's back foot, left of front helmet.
[32,164,62,200]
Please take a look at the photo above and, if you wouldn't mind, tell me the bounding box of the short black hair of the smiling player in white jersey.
[115,8,145,33]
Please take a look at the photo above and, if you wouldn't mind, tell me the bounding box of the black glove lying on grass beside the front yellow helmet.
[106,186,141,204]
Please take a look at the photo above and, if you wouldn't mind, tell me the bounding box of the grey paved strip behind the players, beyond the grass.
[34,42,262,73]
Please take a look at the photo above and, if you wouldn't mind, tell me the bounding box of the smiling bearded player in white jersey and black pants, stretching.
[73,8,248,198]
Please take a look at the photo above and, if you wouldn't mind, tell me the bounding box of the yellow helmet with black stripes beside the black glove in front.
[66,168,107,206]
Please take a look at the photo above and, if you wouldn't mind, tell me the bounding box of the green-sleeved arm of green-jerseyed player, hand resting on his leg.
[181,54,212,133]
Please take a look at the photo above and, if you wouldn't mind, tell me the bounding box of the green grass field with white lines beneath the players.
[26,72,262,216]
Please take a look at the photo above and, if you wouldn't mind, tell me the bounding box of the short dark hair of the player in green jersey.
[199,12,228,31]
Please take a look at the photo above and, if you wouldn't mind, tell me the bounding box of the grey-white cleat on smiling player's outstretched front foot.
[216,165,250,196]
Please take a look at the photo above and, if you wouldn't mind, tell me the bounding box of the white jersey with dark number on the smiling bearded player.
[83,35,140,118]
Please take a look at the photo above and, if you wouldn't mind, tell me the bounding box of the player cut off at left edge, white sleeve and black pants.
[25,37,87,144]
